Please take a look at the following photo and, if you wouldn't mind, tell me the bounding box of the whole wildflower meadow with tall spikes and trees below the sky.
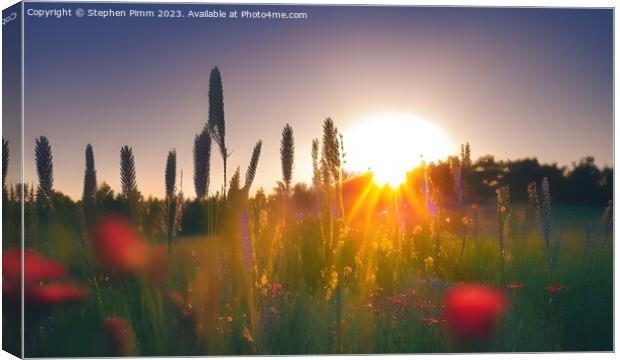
[3,69,613,357]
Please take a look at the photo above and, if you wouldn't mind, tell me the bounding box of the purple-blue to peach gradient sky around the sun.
[18,3,613,198]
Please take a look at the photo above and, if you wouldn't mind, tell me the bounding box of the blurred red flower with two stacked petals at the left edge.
[2,249,88,307]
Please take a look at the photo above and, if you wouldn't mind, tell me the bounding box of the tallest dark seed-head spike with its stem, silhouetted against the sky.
[207,66,230,194]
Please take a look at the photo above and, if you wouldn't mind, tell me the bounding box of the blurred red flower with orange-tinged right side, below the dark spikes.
[94,217,165,279]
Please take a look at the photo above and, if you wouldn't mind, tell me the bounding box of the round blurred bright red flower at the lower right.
[444,284,506,340]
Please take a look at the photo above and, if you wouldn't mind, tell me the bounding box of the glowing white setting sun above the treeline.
[344,113,453,189]
